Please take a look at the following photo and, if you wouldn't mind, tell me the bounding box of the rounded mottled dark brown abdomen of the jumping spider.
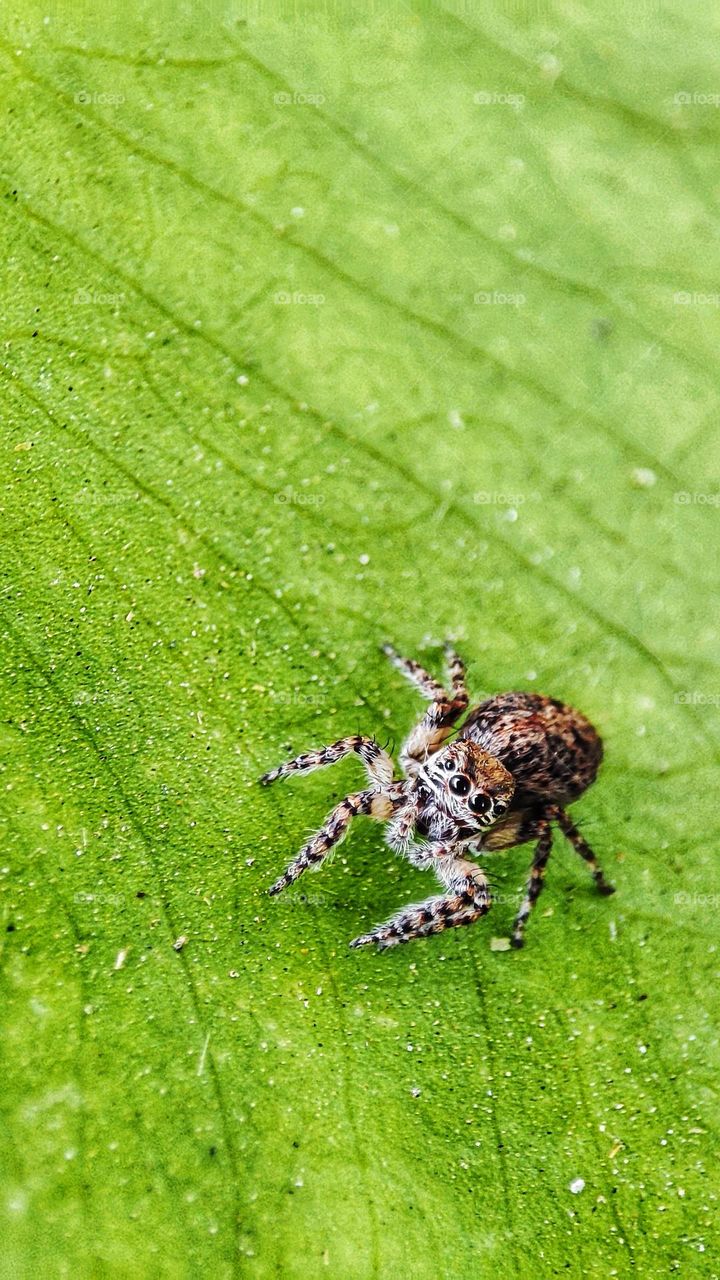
[459,694,602,804]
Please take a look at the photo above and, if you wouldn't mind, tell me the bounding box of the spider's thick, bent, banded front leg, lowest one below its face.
[350,845,492,950]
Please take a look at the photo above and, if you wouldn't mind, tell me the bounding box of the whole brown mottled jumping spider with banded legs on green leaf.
[261,645,614,948]
